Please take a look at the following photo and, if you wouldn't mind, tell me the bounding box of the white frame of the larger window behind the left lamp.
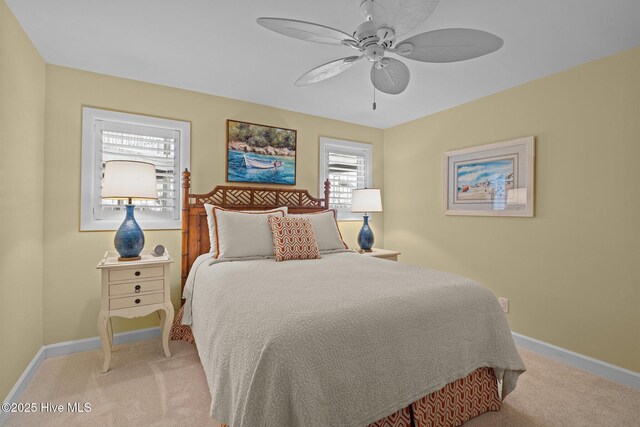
[80,107,191,231]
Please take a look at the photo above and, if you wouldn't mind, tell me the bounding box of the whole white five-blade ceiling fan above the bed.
[257,0,504,110]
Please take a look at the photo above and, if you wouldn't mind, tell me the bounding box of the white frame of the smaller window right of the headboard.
[319,136,373,221]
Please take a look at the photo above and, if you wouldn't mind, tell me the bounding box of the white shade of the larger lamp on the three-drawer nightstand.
[102,160,158,199]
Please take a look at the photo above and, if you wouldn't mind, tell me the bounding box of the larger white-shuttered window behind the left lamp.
[80,107,190,231]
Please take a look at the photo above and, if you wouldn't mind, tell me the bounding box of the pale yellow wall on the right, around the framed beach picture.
[384,48,640,371]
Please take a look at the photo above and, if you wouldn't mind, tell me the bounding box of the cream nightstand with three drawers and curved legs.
[97,251,174,372]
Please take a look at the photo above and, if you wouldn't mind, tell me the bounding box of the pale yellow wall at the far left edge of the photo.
[0,0,45,400]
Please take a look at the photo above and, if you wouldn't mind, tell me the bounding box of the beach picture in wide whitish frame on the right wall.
[444,136,535,217]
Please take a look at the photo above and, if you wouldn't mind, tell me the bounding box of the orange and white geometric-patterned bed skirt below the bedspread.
[171,308,500,427]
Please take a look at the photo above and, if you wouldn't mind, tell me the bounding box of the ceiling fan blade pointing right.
[390,28,504,62]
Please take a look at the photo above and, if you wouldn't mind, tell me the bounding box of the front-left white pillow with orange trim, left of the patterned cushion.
[212,206,285,259]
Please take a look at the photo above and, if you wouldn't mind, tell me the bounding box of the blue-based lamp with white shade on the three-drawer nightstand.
[102,160,158,261]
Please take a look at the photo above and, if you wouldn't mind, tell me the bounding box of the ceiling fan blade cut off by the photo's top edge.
[360,0,440,36]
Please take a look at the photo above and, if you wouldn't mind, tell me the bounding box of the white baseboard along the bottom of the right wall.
[511,332,640,389]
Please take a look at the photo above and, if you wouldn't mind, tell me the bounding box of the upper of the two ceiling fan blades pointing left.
[256,18,359,49]
